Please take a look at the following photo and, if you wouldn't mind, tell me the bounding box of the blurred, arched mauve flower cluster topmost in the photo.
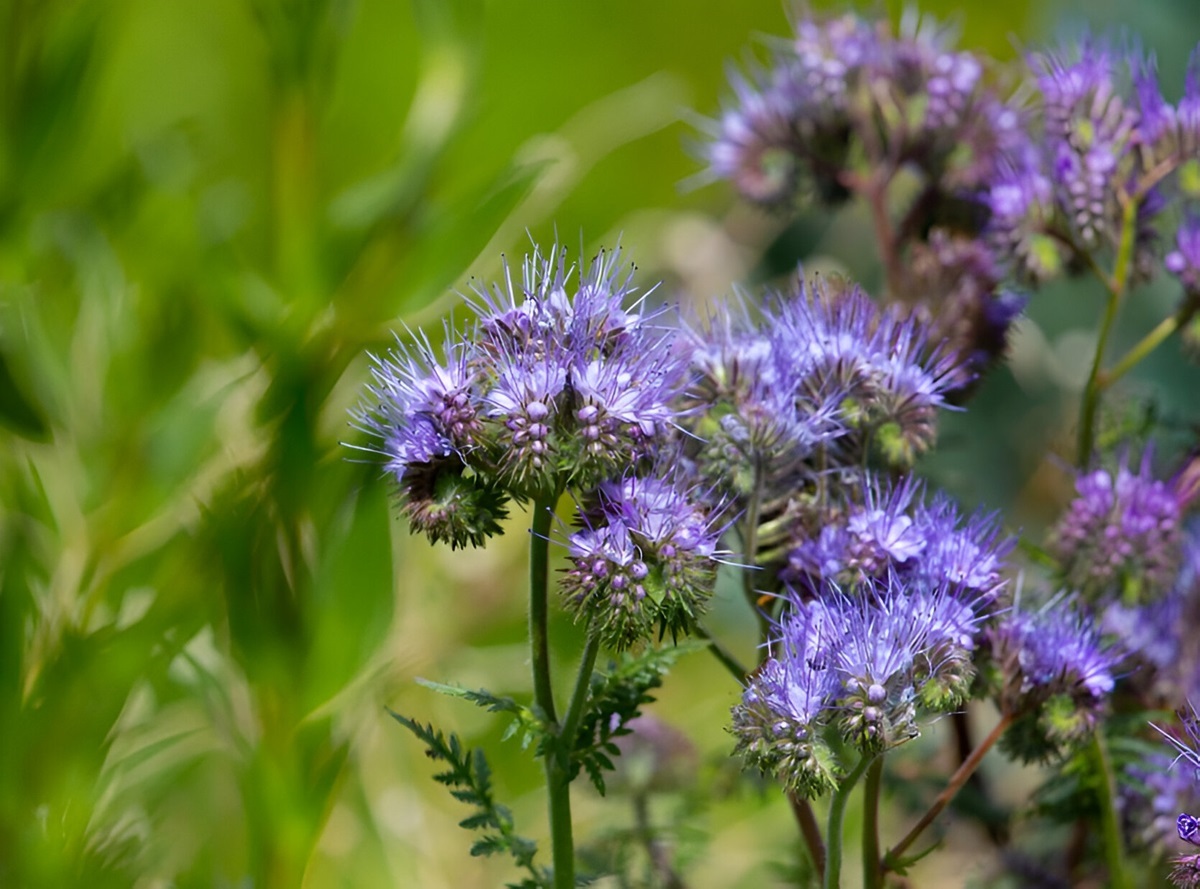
[708,16,1021,204]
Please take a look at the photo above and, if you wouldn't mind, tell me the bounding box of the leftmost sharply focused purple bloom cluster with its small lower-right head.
[358,247,721,648]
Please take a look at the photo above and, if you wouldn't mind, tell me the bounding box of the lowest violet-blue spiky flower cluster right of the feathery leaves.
[733,578,986,797]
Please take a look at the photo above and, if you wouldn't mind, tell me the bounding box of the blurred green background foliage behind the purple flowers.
[0,0,1200,888]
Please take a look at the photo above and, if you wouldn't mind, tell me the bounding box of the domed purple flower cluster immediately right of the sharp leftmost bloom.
[678,281,956,495]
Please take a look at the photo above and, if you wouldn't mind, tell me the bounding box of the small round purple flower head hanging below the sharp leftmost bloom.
[562,475,724,649]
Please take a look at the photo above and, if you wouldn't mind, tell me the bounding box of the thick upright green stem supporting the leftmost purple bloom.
[529,497,575,889]
